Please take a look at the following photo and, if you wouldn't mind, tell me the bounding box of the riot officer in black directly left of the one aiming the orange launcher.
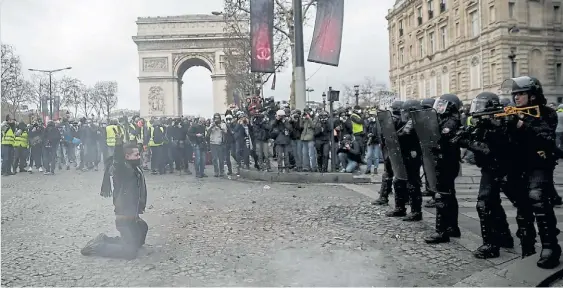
[458,92,514,259]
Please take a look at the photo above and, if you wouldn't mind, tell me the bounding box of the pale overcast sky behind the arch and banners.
[0,0,395,115]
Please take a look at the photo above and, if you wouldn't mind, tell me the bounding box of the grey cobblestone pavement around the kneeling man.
[1,171,492,286]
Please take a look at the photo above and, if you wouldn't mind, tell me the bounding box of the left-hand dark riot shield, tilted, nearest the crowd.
[377,111,408,180]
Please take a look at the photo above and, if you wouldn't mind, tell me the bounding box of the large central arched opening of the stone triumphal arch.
[176,58,213,117]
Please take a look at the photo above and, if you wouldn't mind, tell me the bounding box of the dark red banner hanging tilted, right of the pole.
[307,0,344,66]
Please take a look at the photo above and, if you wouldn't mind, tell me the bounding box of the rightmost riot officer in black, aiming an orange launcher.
[502,76,561,269]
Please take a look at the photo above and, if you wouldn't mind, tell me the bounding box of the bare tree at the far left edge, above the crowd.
[0,44,22,103]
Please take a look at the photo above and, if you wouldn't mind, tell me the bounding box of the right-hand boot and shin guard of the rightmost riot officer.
[536,212,561,269]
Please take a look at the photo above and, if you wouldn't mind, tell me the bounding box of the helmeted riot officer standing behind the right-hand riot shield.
[424,94,462,244]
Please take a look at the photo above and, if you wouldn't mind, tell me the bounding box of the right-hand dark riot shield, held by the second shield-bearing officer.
[410,109,440,192]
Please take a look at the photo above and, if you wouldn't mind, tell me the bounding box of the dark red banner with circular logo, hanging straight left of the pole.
[250,0,275,73]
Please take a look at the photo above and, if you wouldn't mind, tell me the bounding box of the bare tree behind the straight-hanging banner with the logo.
[223,0,316,107]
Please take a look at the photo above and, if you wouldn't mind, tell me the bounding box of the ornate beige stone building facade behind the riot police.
[386,0,563,103]
